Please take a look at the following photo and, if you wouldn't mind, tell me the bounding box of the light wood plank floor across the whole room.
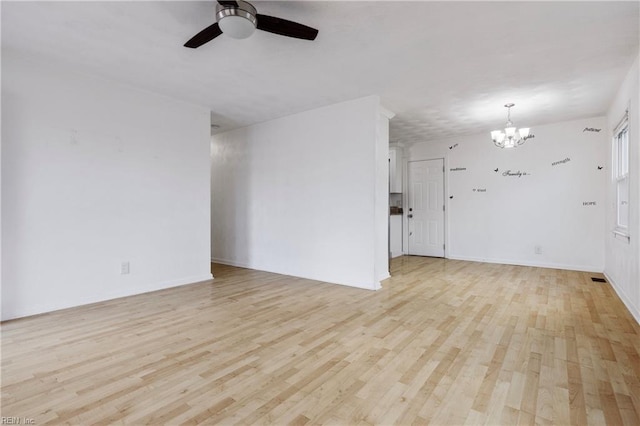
[2,257,640,425]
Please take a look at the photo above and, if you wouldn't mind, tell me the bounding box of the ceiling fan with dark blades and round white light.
[184,0,318,49]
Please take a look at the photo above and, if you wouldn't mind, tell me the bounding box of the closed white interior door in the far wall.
[407,158,444,257]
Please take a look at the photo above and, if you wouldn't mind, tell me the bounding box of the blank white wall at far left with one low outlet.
[2,51,211,319]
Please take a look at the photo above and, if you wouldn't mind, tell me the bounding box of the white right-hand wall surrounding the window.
[605,54,640,323]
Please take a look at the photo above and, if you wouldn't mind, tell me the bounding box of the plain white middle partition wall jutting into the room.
[211,96,388,289]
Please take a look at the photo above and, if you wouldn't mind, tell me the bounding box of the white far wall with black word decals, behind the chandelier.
[405,117,609,272]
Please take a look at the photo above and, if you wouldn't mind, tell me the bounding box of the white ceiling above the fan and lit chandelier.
[1,1,640,143]
